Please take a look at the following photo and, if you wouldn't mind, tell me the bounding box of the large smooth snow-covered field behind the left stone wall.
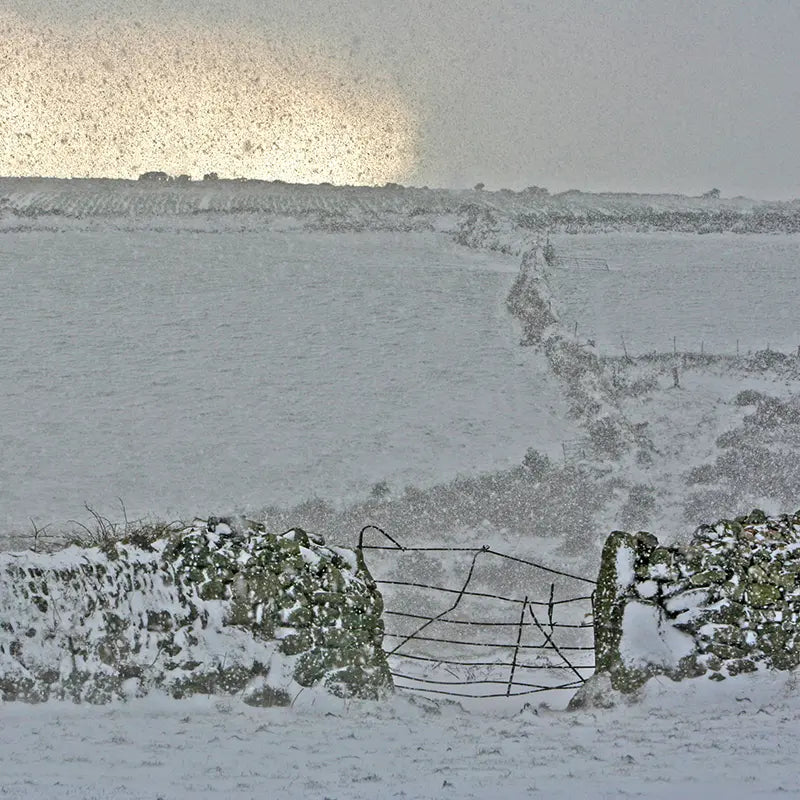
[0,228,574,532]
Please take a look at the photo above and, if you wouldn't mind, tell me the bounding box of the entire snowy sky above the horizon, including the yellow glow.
[0,0,800,199]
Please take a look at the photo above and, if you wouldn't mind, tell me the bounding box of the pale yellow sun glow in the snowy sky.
[0,16,418,184]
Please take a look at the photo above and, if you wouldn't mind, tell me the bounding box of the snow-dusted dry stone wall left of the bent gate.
[0,518,392,705]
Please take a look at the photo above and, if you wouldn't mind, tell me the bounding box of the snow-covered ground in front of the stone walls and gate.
[0,673,800,800]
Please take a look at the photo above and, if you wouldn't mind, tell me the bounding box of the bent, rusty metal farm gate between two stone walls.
[358,525,596,698]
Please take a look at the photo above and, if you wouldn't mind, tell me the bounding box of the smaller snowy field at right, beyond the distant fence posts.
[550,233,800,355]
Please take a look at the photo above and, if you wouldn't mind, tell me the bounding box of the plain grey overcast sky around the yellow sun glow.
[6,0,800,199]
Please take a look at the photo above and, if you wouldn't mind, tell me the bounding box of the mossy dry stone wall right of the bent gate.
[595,509,800,692]
